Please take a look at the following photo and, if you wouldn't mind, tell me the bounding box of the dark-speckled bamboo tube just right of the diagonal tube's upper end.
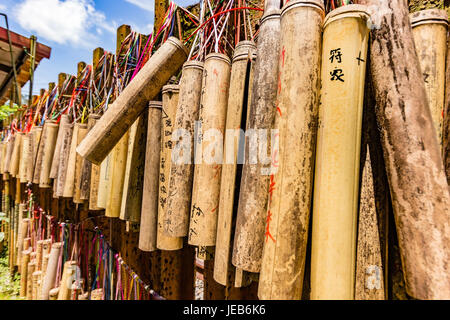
[164,61,203,237]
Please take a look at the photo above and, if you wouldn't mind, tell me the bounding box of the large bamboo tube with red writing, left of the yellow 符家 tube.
[256,0,324,300]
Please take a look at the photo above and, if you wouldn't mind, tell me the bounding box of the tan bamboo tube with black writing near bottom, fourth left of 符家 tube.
[189,53,231,246]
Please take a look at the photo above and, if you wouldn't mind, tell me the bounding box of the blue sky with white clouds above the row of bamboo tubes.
[0,0,198,94]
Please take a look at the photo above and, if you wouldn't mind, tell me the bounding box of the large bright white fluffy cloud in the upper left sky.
[14,0,116,46]
